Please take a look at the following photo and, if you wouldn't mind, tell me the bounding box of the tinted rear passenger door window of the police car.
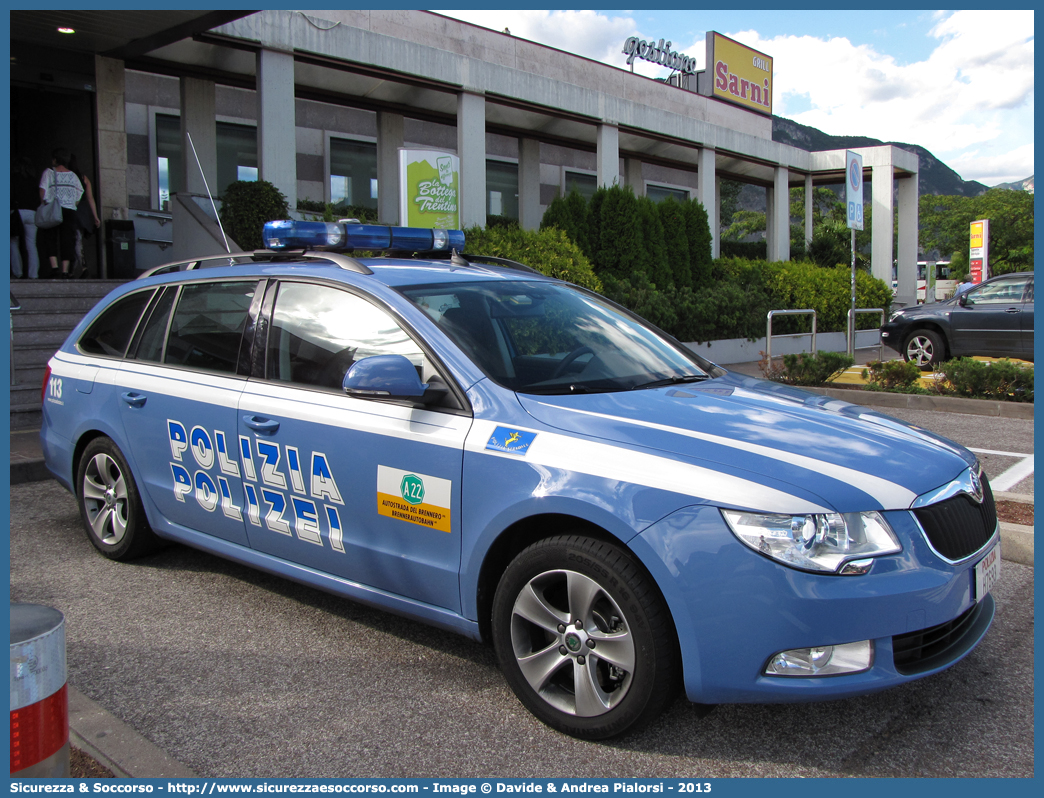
[165,280,257,374]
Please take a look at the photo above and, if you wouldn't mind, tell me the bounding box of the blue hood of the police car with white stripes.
[519,374,975,512]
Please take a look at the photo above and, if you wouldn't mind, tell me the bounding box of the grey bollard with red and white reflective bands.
[10,603,69,778]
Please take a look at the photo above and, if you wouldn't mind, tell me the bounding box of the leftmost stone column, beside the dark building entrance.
[94,55,128,277]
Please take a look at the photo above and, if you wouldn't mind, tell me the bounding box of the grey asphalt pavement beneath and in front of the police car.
[10,463,1034,778]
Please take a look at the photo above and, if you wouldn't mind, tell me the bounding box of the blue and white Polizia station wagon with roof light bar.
[41,221,1000,738]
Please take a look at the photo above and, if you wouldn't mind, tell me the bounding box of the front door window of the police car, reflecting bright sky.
[265,282,435,392]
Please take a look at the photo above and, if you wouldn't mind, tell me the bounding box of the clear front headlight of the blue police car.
[721,510,902,574]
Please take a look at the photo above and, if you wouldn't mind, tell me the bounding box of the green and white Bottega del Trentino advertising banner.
[399,149,460,230]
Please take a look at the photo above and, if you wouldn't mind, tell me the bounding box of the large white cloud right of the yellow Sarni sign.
[732,10,1034,173]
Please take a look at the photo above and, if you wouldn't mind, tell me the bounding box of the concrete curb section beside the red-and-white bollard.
[69,684,196,778]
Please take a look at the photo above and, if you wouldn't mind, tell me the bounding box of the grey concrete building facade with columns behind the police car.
[11,9,918,302]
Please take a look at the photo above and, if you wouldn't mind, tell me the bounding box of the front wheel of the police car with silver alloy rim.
[493,536,680,740]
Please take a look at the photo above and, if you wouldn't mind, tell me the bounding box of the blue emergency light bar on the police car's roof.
[262,219,464,252]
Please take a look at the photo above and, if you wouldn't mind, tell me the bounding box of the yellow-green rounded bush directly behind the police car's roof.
[464,227,602,291]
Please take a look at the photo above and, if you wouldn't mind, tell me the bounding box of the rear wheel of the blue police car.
[76,438,161,561]
